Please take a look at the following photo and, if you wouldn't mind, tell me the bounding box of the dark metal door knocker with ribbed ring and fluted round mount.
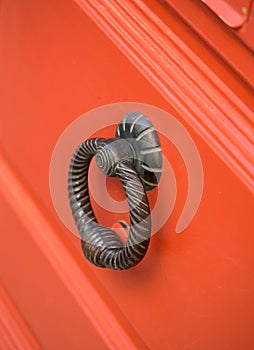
[68,112,162,270]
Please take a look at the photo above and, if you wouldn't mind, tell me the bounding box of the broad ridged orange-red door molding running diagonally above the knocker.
[75,0,254,191]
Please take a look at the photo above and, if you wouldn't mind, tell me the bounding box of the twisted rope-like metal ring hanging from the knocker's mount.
[68,138,151,270]
